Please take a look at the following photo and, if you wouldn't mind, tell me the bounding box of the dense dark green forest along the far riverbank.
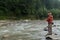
[0,0,60,20]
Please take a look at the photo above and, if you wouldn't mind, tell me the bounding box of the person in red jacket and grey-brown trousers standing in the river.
[47,12,53,35]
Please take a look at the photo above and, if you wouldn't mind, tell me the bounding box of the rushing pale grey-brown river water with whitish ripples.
[0,20,60,40]
